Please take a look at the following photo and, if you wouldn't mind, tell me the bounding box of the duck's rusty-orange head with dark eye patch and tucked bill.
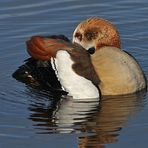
[73,17,121,53]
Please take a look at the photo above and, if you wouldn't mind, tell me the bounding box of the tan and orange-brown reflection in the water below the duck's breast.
[79,91,145,148]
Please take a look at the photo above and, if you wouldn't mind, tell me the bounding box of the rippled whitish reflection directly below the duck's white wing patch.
[55,98,99,133]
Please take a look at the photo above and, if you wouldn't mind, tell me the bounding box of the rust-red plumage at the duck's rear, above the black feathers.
[26,36,69,61]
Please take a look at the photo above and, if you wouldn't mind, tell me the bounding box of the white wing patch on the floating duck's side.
[51,50,99,99]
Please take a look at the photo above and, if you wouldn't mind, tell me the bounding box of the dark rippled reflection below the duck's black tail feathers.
[26,87,62,133]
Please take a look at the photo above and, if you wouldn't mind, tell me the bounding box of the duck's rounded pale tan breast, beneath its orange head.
[92,47,146,95]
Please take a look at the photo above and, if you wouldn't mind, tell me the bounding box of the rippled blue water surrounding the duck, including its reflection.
[0,0,148,148]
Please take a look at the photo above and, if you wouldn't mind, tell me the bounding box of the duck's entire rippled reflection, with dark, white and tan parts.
[26,86,145,148]
